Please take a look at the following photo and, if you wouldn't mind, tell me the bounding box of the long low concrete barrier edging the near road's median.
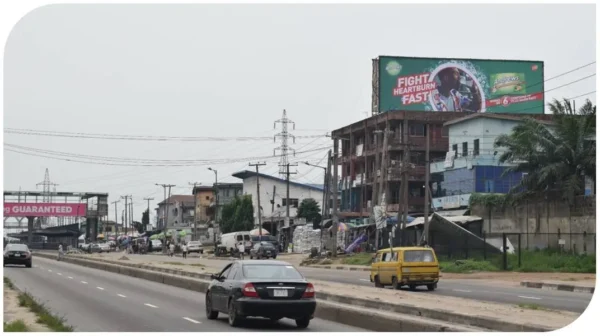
[36,253,552,332]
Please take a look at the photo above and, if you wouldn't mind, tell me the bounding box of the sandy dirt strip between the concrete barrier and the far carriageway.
[52,254,580,329]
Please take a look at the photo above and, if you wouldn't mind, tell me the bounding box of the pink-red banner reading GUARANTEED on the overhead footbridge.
[4,203,87,217]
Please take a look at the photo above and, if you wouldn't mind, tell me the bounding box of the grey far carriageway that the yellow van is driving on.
[142,255,593,313]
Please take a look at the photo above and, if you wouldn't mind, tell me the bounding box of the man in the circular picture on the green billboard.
[433,67,481,112]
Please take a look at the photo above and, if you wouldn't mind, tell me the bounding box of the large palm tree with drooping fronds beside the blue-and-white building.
[495,99,596,204]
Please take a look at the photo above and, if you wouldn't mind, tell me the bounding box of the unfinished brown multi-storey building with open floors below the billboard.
[332,111,467,220]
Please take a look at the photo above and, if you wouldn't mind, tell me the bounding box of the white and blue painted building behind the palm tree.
[430,113,551,209]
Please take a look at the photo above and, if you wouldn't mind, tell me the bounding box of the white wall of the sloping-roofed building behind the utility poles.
[243,176,323,224]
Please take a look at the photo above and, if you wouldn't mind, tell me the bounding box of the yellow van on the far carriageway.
[370,247,440,291]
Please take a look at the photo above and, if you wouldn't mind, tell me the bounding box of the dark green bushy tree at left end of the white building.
[220,195,254,233]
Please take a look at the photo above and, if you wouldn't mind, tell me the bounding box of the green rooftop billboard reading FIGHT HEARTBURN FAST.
[373,56,544,114]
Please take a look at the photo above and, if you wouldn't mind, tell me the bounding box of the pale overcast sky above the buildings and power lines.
[3,4,596,221]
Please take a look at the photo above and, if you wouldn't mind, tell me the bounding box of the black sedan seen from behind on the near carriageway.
[206,260,317,328]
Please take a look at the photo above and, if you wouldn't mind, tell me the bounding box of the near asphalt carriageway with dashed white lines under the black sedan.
[4,258,366,332]
